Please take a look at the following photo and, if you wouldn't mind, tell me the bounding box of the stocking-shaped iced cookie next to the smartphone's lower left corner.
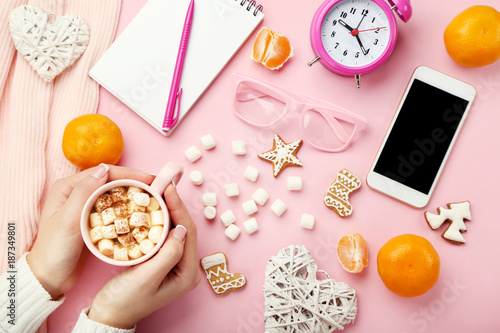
[323,169,361,217]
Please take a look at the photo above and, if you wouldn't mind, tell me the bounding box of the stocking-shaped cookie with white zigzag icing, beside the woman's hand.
[200,252,247,295]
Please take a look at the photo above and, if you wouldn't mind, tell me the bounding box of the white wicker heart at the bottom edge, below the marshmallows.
[263,245,358,333]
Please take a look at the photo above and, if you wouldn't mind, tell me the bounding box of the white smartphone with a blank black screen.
[366,66,476,208]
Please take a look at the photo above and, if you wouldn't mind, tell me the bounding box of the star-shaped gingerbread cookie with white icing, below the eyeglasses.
[258,134,302,177]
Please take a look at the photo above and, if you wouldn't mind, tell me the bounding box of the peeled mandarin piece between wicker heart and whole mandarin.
[337,233,368,273]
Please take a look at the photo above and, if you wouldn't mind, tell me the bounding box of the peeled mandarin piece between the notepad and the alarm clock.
[252,27,293,70]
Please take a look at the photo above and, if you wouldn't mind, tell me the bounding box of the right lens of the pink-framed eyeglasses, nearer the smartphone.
[304,108,354,150]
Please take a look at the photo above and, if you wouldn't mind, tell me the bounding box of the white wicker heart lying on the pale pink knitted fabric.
[9,6,90,82]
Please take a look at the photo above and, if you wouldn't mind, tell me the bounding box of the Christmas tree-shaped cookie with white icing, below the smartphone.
[424,201,471,244]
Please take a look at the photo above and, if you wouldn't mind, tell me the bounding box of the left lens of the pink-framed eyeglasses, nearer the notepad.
[235,82,286,126]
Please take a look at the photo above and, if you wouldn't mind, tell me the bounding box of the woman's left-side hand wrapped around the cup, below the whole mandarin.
[26,164,154,300]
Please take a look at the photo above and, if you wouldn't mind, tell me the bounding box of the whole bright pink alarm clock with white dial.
[309,0,412,88]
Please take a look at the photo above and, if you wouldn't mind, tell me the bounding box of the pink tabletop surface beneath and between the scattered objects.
[49,0,500,332]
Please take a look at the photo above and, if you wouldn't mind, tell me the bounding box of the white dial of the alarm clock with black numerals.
[321,0,395,68]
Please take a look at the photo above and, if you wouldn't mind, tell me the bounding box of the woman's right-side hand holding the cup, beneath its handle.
[88,184,201,329]
